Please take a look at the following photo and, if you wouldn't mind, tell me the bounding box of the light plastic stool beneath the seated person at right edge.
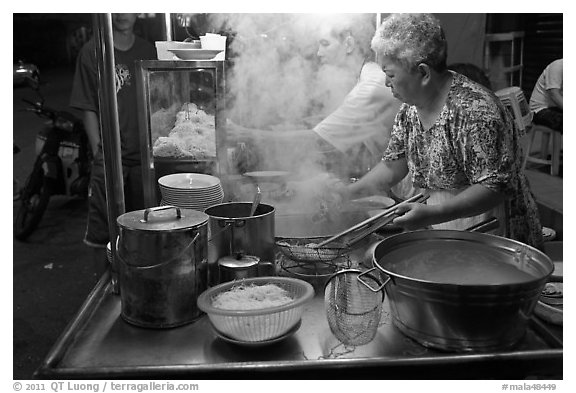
[524,124,562,176]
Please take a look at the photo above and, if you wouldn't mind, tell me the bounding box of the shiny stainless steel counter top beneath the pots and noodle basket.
[35,273,563,379]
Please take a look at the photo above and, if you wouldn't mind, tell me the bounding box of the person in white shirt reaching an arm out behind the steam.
[228,16,401,185]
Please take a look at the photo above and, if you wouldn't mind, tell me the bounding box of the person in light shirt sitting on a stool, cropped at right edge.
[530,59,563,133]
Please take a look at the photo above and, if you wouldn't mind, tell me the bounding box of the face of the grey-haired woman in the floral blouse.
[379,57,421,105]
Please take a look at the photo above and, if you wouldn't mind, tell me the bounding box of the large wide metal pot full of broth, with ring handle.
[373,230,554,352]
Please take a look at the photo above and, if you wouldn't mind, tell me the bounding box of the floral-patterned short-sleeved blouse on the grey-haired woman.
[382,71,542,247]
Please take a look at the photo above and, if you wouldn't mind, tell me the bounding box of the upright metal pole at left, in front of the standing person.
[93,14,126,292]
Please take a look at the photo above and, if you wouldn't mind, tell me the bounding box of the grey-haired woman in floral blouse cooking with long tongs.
[344,14,542,247]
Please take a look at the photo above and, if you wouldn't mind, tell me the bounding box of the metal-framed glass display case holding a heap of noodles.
[135,60,226,207]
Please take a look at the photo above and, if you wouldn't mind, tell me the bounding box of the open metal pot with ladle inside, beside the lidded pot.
[205,202,276,286]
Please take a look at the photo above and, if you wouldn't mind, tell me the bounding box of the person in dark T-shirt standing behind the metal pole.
[70,14,156,260]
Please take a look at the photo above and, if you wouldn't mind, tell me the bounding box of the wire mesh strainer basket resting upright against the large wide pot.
[324,269,384,346]
